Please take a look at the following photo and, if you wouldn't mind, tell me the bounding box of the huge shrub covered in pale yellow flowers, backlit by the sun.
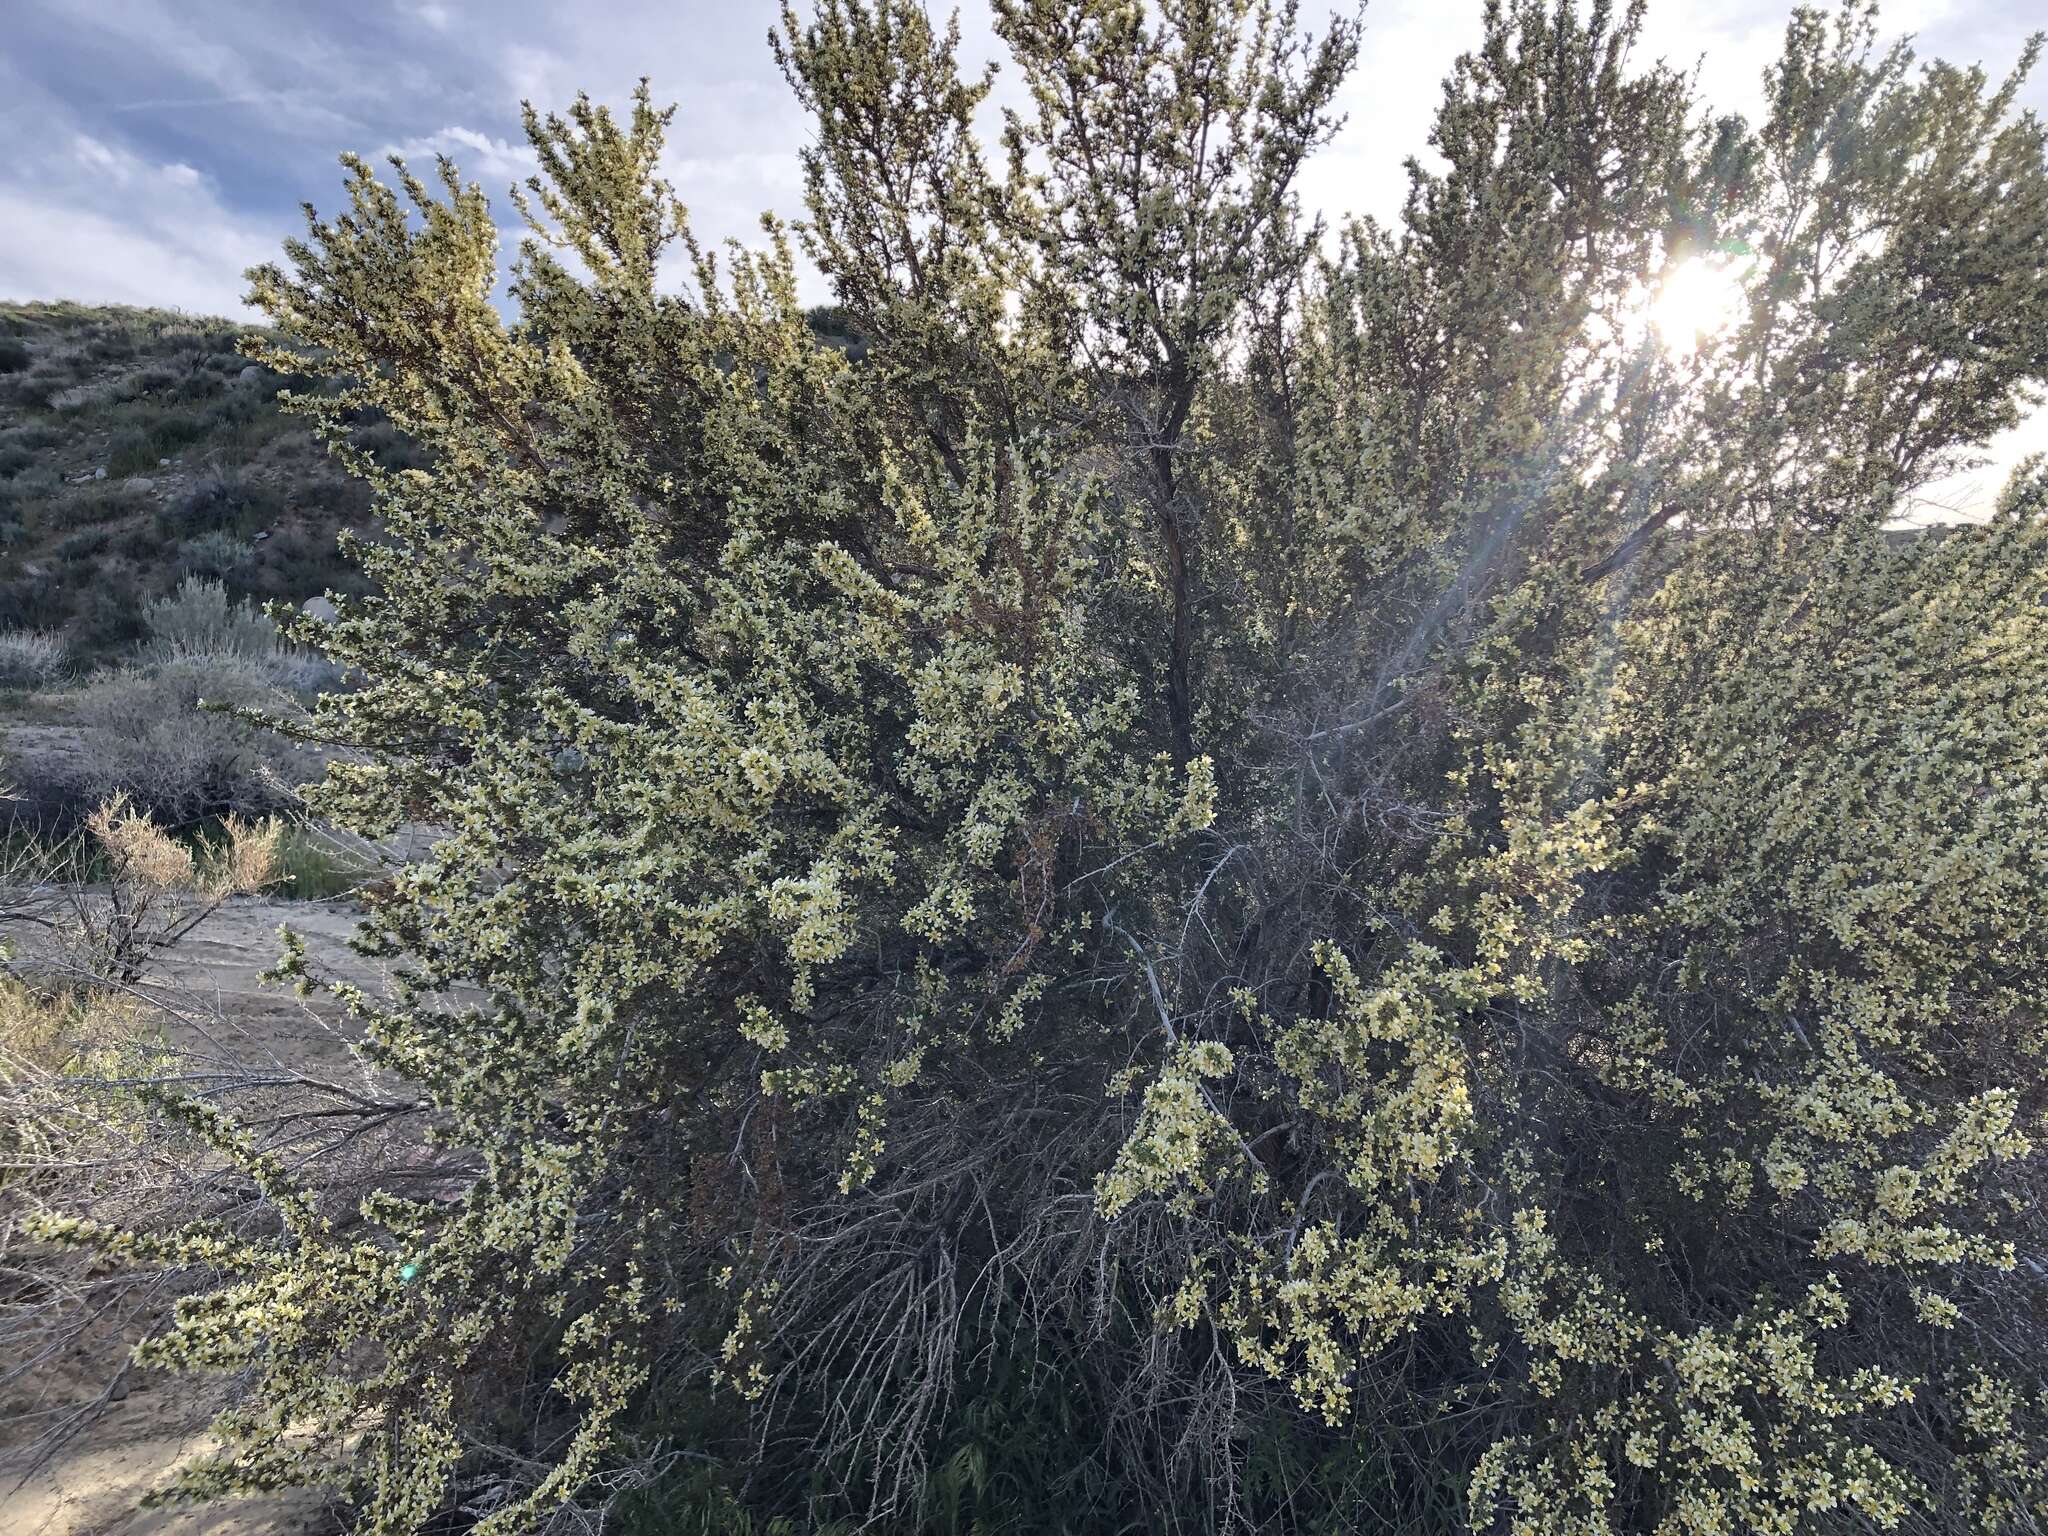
[24,0,2048,1536]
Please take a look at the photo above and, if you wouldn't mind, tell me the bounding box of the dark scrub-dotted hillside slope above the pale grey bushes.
[0,303,391,672]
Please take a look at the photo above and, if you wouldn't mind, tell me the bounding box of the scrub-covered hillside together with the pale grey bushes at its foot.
[0,303,418,843]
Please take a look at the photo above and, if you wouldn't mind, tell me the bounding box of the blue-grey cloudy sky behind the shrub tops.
[0,0,2048,514]
